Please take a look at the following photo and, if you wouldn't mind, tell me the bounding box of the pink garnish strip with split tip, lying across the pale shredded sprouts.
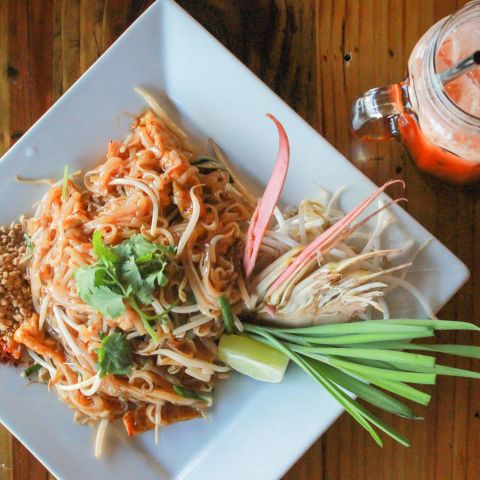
[267,180,405,296]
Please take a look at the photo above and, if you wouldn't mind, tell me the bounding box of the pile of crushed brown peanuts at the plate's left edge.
[0,223,35,363]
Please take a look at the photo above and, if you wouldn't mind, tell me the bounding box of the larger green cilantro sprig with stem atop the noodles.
[75,231,175,342]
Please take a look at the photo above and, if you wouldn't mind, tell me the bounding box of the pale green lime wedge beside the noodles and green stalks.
[218,335,288,383]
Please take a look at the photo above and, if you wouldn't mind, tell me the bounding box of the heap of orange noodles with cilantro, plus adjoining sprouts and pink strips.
[1,96,478,454]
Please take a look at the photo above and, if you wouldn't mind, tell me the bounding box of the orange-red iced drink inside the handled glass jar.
[398,14,480,183]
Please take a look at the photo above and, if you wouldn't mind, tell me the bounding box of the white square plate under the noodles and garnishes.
[0,0,468,480]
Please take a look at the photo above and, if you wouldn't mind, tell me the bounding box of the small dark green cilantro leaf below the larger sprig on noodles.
[97,332,133,378]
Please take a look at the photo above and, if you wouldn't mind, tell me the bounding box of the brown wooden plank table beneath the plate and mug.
[0,0,480,480]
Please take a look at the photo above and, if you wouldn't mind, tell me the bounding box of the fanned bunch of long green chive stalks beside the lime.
[239,320,480,446]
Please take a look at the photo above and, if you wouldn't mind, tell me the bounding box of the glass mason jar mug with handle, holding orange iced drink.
[352,0,480,185]
